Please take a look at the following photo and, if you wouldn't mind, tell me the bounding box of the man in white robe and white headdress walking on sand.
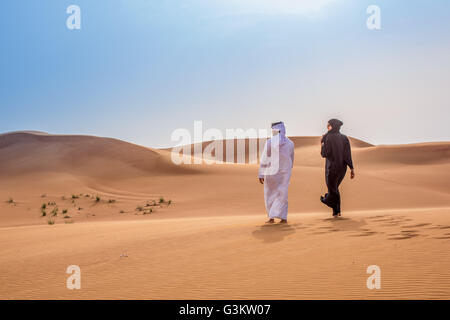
[258,122,294,223]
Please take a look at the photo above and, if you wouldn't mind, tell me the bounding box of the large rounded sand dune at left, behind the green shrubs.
[0,132,195,179]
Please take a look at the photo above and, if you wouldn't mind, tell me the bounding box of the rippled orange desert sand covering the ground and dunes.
[0,132,450,299]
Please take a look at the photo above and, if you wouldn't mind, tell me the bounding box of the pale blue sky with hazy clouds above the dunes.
[0,0,450,147]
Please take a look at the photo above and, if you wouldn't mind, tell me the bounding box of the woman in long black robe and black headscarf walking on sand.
[320,119,355,217]
